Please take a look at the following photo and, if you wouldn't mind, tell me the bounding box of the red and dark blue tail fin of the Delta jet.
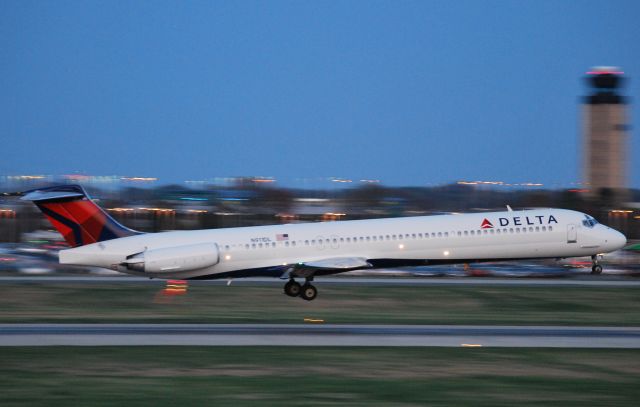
[21,185,140,247]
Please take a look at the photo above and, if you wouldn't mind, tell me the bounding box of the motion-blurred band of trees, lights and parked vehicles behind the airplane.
[0,166,640,276]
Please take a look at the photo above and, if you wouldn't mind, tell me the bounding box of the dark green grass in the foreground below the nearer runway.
[0,347,640,407]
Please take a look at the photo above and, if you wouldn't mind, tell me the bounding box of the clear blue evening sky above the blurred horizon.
[0,0,640,187]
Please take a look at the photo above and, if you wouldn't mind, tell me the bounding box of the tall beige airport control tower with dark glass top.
[582,67,628,196]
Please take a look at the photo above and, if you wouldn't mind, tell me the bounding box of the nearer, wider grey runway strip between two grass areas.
[0,324,640,349]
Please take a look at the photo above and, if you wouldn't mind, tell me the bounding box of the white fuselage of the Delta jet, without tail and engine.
[60,209,626,278]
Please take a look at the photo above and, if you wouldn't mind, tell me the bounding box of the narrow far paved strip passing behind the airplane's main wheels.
[0,276,640,287]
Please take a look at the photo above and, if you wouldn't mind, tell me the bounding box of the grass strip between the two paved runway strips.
[0,283,640,326]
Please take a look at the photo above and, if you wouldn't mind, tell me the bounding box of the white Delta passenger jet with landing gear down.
[3,185,627,301]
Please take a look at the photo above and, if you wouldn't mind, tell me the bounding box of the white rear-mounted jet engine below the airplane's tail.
[122,243,220,273]
